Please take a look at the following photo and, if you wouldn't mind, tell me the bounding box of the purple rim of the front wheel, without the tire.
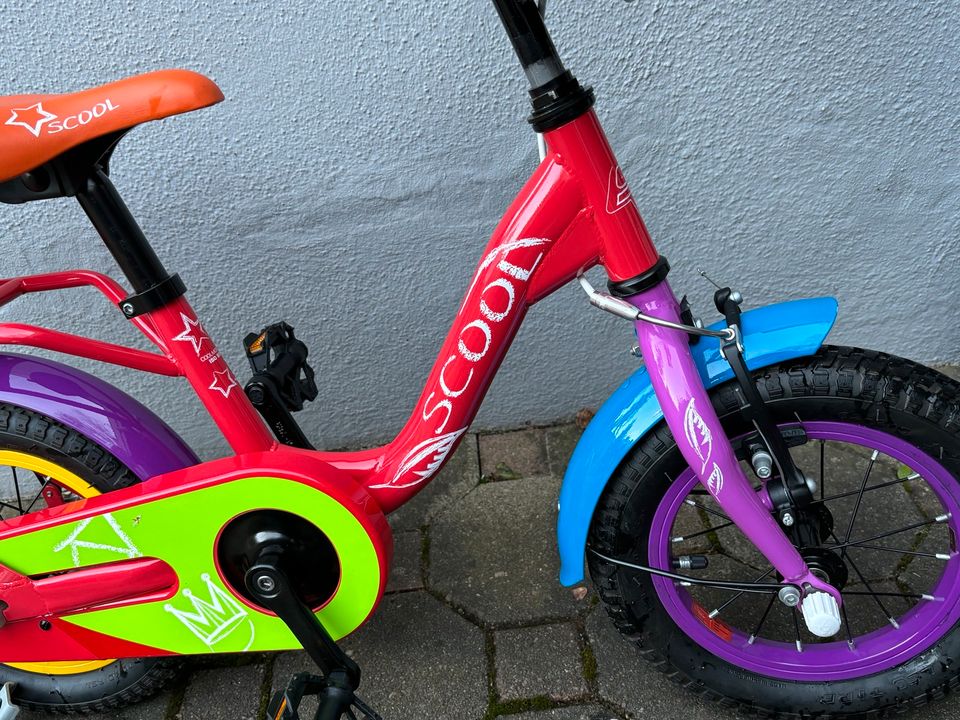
[648,422,960,682]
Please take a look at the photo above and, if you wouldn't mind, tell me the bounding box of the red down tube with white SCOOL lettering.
[364,155,597,512]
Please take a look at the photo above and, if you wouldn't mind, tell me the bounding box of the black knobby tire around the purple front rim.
[588,347,960,718]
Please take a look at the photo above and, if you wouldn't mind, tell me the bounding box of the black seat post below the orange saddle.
[77,165,170,294]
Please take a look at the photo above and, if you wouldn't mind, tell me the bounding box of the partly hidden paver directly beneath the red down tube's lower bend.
[390,434,480,531]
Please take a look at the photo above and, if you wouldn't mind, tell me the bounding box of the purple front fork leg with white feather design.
[628,281,841,603]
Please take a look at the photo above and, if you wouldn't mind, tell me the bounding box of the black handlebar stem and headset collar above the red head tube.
[493,0,594,133]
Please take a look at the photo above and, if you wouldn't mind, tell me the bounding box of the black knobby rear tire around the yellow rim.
[0,403,181,713]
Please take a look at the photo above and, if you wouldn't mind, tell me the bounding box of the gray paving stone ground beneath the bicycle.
[20,402,960,720]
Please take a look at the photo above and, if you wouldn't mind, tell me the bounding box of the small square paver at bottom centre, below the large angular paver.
[493,623,589,700]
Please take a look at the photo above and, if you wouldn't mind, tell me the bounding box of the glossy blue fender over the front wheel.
[557,298,837,586]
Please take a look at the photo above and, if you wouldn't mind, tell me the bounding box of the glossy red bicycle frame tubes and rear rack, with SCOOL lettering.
[0,111,658,512]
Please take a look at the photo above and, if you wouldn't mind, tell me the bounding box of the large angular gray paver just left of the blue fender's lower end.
[427,478,584,625]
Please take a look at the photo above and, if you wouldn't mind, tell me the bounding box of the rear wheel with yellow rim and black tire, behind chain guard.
[0,403,179,713]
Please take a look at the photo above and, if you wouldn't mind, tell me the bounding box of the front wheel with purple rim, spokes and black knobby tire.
[589,347,960,718]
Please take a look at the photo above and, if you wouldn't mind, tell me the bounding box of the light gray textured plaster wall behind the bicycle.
[0,0,960,455]
